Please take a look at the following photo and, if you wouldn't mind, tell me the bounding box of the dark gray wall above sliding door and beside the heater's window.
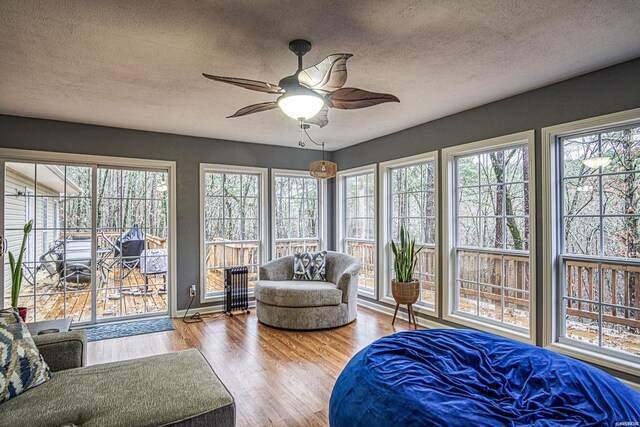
[0,115,334,310]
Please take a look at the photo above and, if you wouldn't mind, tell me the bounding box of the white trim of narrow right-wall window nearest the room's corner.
[336,164,378,300]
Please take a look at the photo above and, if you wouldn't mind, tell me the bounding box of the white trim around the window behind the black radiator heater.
[199,163,269,304]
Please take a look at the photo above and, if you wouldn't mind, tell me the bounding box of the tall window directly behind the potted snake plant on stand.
[381,153,438,313]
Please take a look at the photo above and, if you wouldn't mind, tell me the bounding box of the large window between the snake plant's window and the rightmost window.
[445,132,533,340]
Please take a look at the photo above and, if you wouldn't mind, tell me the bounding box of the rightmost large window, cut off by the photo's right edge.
[545,114,640,369]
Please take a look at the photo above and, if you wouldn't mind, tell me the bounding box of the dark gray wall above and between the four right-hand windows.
[333,58,640,381]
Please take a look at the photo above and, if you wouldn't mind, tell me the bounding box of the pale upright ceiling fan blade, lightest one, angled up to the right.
[298,53,353,92]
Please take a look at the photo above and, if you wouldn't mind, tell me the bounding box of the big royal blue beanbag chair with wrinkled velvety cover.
[329,329,640,427]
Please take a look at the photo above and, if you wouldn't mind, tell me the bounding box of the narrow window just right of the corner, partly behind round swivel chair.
[338,166,377,296]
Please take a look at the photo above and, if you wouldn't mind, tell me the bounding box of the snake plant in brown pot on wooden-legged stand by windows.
[391,226,423,328]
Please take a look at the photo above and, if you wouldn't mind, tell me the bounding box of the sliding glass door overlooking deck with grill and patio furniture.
[1,160,169,323]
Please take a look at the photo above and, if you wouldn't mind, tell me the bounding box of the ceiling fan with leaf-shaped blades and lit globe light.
[202,40,400,127]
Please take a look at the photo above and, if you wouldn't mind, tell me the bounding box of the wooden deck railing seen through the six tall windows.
[207,240,640,329]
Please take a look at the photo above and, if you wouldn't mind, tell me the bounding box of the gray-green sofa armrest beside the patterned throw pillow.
[33,330,87,372]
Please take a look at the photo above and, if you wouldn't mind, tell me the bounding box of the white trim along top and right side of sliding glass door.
[0,148,178,317]
